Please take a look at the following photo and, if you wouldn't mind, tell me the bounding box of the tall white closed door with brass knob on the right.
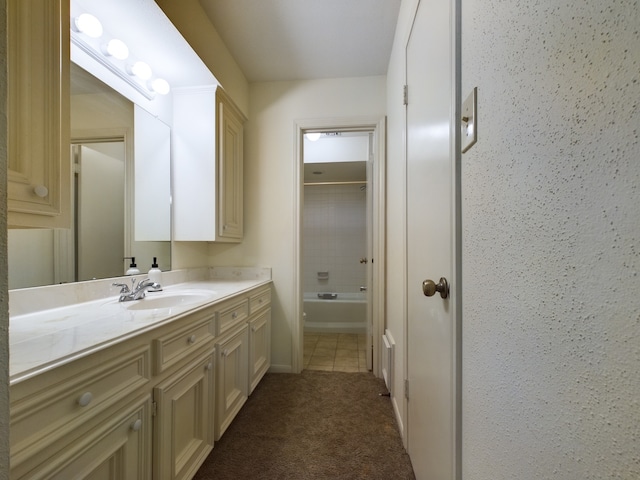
[406,0,457,480]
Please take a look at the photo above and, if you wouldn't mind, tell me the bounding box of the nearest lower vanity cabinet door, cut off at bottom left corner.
[12,395,151,480]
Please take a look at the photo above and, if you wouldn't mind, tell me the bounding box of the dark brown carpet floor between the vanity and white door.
[194,370,415,480]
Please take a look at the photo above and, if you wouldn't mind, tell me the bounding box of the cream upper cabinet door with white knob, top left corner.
[7,0,71,228]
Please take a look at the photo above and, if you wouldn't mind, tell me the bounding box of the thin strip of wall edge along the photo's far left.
[0,0,9,474]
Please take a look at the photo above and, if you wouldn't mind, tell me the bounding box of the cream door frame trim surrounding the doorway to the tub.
[292,118,385,376]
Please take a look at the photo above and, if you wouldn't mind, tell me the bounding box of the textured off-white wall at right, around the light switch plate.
[462,0,640,480]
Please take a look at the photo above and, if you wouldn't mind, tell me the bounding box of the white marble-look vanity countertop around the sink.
[9,278,271,384]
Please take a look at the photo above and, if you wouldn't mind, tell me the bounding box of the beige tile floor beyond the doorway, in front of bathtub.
[304,332,368,372]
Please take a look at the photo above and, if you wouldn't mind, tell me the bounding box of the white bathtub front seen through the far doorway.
[303,293,367,333]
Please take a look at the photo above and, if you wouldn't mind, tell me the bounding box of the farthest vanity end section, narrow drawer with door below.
[249,288,271,395]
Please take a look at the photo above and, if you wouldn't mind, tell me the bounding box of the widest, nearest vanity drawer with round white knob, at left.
[10,343,150,465]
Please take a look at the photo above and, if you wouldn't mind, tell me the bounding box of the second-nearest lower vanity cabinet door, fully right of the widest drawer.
[154,353,214,480]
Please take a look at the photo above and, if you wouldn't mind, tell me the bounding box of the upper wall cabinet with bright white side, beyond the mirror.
[172,87,246,242]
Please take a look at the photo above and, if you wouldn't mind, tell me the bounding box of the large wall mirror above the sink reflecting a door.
[8,64,171,289]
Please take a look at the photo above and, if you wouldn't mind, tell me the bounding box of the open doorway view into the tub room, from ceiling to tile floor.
[302,130,373,372]
